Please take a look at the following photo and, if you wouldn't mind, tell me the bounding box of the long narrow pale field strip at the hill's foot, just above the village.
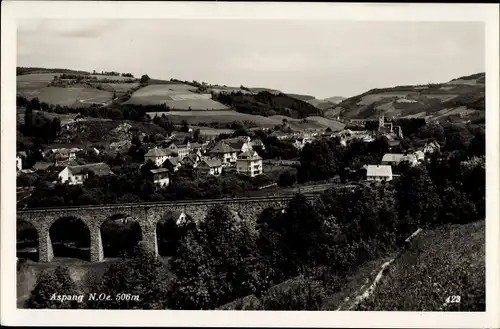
[148,110,344,130]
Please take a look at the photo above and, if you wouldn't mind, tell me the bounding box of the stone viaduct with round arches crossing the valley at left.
[17,196,316,262]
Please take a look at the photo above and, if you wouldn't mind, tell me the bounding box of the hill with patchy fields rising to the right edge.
[325,73,485,119]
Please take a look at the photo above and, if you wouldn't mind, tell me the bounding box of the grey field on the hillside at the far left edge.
[18,87,113,107]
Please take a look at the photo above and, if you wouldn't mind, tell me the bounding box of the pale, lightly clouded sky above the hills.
[17,19,485,98]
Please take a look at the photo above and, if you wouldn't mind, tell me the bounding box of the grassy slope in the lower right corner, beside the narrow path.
[358,220,485,311]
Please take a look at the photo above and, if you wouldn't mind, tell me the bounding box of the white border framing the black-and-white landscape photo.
[0,1,500,328]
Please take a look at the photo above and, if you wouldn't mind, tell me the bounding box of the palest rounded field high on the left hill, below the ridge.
[125,84,227,110]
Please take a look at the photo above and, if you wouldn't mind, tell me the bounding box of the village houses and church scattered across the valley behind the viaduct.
[16,112,440,192]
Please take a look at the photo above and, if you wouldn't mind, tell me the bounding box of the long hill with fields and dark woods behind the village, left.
[17,67,343,130]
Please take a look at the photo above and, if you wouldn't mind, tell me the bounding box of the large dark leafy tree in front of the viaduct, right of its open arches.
[171,206,260,309]
